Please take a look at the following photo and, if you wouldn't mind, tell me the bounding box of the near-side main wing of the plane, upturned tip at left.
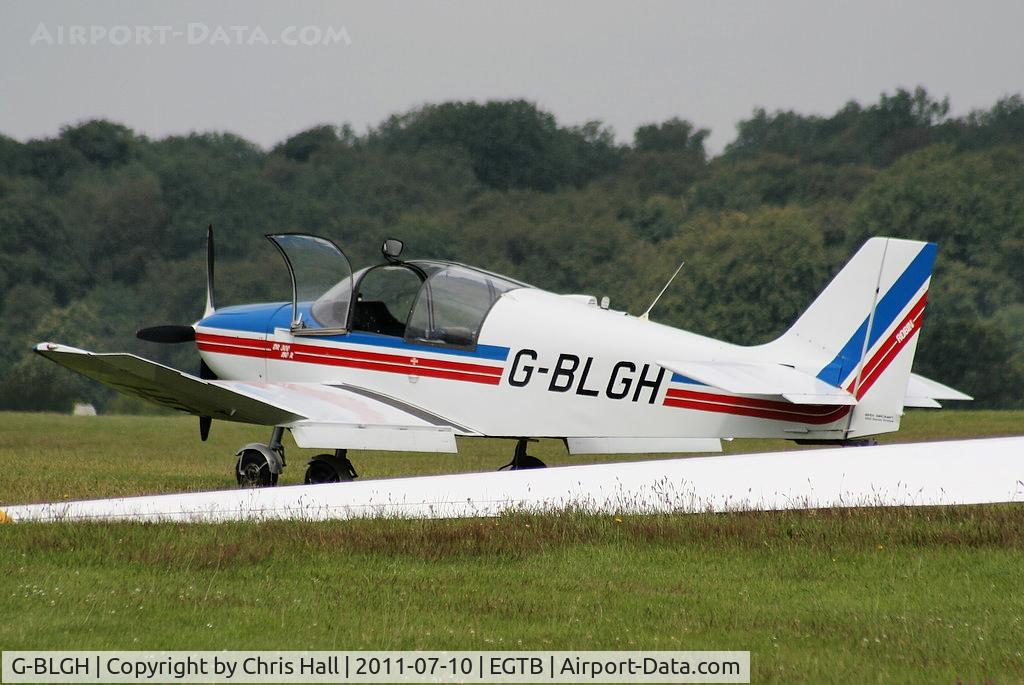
[35,343,462,453]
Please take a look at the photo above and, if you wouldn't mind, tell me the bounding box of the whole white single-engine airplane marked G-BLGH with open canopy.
[35,230,970,486]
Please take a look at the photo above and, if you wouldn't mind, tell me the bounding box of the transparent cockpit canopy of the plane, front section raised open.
[267,233,529,347]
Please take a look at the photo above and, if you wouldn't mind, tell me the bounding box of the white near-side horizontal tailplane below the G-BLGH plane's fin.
[657,361,857,404]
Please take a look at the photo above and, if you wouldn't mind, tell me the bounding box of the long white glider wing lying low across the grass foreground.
[0,437,1024,522]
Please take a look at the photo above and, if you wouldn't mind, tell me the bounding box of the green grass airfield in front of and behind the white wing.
[0,412,1024,683]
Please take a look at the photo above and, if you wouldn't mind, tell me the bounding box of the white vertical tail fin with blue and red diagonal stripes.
[770,238,937,437]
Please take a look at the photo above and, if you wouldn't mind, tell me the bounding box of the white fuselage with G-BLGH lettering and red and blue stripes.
[197,288,876,439]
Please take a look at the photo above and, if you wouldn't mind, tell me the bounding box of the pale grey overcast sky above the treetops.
[0,0,1024,152]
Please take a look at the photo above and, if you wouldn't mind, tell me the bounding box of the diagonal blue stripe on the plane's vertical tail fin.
[818,243,938,386]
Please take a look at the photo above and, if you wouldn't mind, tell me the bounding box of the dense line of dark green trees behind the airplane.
[0,88,1024,411]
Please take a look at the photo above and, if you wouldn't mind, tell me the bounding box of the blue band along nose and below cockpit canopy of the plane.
[199,302,509,361]
